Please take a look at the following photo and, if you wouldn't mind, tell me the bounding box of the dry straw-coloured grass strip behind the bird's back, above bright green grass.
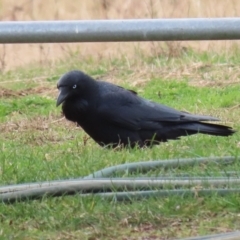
[102,60,240,88]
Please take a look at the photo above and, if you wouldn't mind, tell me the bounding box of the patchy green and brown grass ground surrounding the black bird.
[0,51,240,240]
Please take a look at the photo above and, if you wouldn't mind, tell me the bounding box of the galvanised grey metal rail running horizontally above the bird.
[0,18,240,43]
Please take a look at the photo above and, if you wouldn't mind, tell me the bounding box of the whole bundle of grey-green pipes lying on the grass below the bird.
[0,157,240,203]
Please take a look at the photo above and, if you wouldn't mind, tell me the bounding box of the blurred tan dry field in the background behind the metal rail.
[0,0,240,70]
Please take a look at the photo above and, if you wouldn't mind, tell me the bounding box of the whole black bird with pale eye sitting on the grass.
[57,71,235,147]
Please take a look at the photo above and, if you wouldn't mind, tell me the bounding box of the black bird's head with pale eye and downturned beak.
[57,71,94,106]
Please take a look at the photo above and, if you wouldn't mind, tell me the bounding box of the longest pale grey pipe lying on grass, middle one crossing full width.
[0,178,240,195]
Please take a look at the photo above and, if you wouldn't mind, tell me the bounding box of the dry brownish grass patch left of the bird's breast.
[0,113,86,146]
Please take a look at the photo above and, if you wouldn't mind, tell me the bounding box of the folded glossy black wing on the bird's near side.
[98,85,218,131]
